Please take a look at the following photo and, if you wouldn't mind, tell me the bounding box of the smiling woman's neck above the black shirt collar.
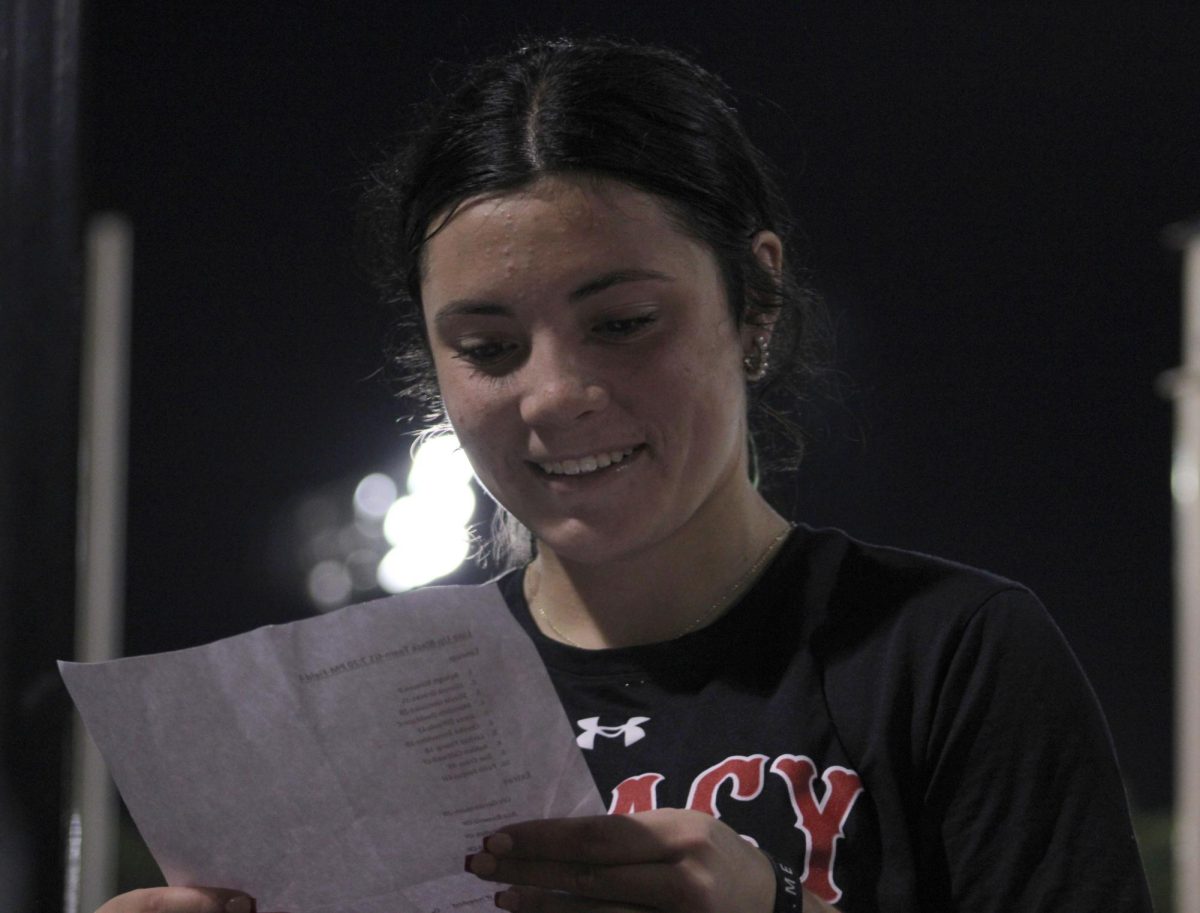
[526,492,791,649]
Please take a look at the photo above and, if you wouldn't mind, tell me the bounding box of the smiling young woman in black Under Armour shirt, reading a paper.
[96,35,1150,913]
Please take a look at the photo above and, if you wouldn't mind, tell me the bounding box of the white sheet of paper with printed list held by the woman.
[60,584,605,913]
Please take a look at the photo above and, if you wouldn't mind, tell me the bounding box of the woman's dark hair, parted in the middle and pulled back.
[360,38,827,556]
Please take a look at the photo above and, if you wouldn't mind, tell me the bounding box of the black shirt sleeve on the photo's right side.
[920,589,1151,913]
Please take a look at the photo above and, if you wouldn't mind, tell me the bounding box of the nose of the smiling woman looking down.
[521,343,608,427]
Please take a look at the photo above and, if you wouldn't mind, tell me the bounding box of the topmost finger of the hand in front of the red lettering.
[484,809,707,865]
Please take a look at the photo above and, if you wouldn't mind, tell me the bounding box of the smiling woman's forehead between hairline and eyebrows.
[421,176,715,299]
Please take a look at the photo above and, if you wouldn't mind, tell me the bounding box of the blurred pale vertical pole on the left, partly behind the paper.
[65,215,133,913]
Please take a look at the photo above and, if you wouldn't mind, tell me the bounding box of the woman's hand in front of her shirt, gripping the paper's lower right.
[467,809,775,913]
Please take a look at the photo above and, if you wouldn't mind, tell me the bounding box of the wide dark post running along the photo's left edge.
[0,0,83,911]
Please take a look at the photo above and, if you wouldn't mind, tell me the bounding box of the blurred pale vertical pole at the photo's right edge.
[1171,227,1200,913]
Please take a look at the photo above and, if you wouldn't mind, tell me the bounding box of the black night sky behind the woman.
[84,0,1200,805]
